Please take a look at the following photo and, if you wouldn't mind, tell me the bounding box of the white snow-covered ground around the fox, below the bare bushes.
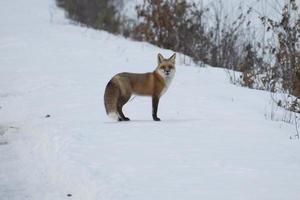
[0,0,300,200]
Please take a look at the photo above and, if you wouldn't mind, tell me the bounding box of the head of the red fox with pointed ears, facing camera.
[156,53,176,78]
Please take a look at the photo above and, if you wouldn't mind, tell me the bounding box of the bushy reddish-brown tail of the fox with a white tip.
[104,79,120,120]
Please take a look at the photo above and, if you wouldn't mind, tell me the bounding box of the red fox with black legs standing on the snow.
[104,53,176,121]
